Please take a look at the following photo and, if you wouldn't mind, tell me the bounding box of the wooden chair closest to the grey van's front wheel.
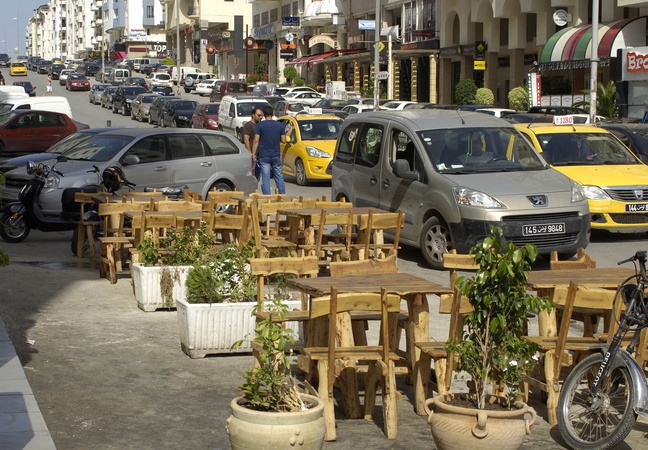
[353,211,405,259]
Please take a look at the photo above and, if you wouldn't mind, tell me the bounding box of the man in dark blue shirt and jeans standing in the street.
[252,106,286,194]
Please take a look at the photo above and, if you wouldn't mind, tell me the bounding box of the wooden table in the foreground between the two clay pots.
[286,273,452,417]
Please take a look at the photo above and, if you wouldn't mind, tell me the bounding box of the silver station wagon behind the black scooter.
[0,127,258,215]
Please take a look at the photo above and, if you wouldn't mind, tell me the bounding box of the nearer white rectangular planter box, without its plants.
[176,299,301,358]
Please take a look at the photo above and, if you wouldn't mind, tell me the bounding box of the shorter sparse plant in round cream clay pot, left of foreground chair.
[227,293,326,450]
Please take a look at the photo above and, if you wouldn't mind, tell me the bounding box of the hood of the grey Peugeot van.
[444,169,571,197]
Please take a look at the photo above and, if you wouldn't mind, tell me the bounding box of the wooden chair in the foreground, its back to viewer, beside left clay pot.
[298,287,400,441]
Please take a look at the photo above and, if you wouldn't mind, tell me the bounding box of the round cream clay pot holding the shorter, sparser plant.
[227,394,326,450]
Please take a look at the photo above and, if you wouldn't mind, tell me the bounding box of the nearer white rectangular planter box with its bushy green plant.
[176,241,301,358]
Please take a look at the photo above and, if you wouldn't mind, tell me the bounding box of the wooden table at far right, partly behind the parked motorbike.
[527,267,635,336]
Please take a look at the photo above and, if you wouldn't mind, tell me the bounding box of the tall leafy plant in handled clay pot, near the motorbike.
[426,227,552,450]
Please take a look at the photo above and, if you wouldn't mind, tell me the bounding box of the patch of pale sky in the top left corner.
[0,0,41,57]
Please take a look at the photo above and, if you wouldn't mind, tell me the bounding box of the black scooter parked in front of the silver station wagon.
[0,155,135,254]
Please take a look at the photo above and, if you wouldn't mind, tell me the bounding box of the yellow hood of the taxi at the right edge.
[554,164,648,186]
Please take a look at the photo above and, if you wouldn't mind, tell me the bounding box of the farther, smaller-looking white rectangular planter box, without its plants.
[133,264,193,311]
